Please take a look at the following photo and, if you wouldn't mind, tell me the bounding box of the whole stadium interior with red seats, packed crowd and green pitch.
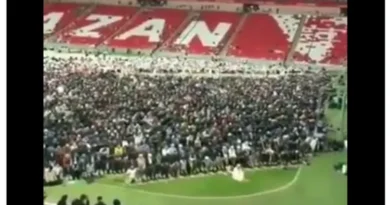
[43,0,348,205]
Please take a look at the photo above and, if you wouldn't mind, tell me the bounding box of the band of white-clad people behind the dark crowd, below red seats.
[44,50,308,77]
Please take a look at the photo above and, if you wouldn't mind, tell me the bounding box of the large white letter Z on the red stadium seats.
[71,14,123,38]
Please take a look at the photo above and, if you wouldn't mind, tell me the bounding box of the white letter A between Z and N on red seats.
[115,19,165,43]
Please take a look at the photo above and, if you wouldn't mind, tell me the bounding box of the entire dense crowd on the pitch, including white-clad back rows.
[43,50,338,187]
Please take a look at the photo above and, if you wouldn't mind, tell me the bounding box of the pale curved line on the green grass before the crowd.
[96,167,302,200]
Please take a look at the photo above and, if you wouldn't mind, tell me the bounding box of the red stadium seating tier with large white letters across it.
[44,4,347,65]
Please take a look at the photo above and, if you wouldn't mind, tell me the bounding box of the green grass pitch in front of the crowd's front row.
[45,152,347,205]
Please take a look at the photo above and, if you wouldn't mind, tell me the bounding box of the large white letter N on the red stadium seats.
[175,21,231,47]
